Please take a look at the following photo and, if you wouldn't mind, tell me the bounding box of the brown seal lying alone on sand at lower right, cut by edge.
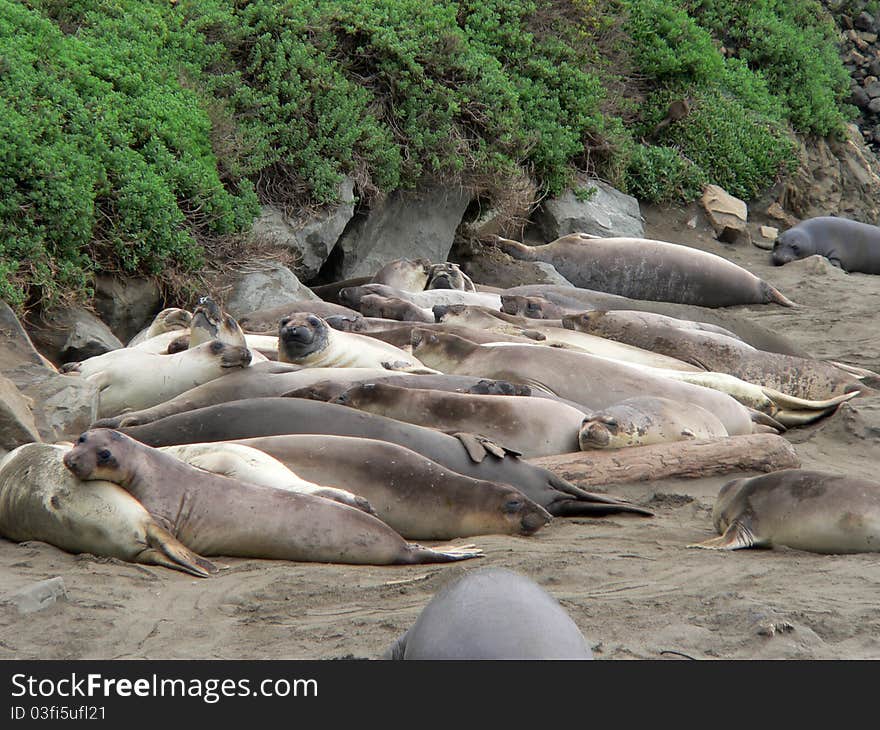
[688,469,880,553]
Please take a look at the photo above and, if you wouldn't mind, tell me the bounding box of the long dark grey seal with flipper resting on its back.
[123,398,652,516]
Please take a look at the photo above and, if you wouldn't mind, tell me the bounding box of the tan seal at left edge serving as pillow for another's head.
[0,443,217,578]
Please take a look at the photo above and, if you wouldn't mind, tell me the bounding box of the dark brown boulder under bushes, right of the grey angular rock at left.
[93,274,163,342]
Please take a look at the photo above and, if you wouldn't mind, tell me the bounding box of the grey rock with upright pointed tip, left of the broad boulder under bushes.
[253,178,354,281]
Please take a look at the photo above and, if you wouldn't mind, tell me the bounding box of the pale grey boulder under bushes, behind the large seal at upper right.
[535,178,645,241]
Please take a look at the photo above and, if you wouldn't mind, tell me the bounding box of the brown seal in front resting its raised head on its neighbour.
[64,429,482,565]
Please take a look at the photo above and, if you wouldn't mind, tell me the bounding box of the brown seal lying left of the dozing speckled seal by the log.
[333,383,584,459]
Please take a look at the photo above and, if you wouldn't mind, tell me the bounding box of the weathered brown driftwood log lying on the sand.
[528,433,801,487]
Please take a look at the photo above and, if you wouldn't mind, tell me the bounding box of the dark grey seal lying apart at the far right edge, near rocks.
[771,215,880,274]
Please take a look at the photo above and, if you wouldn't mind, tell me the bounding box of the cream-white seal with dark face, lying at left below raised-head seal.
[70,340,251,418]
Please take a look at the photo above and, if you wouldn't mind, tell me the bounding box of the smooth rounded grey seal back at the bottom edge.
[382,568,593,659]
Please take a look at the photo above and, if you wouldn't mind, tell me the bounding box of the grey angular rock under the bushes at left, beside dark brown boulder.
[26,307,123,365]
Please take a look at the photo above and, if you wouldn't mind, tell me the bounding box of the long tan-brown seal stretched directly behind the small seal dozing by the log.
[413,329,752,436]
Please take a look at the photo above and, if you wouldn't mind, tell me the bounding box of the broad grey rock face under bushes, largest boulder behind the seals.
[324,187,471,281]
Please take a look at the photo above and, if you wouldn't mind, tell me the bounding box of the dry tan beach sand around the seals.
[0,209,880,660]
